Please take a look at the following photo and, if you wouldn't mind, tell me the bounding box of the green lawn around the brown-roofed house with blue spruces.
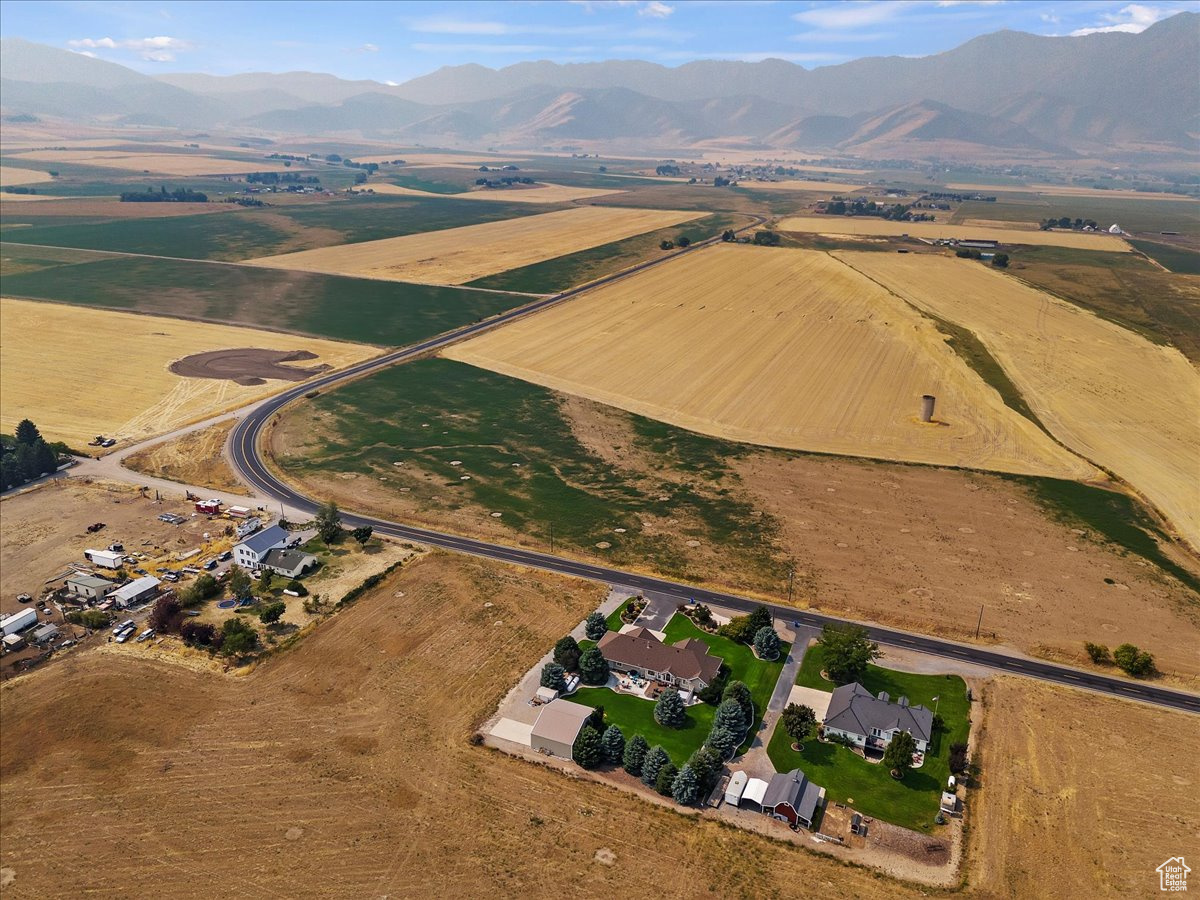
[570,601,788,766]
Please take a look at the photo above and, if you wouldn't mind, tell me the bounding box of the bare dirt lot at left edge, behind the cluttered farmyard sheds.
[0,478,226,614]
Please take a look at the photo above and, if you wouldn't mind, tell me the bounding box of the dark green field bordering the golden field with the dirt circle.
[0,252,529,347]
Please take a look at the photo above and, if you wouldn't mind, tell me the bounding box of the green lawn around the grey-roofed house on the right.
[767,646,971,832]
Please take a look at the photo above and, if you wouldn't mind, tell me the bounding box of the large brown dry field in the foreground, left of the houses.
[0,554,916,900]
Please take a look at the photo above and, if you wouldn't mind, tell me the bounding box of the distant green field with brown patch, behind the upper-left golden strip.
[0,194,548,260]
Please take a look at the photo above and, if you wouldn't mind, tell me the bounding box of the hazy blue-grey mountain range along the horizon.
[0,13,1200,158]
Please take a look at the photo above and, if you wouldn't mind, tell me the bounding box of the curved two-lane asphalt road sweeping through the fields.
[229,220,1200,713]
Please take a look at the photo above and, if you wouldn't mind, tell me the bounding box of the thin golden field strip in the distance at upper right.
[779,216,1129,253]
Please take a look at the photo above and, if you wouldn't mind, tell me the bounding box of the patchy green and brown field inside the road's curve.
[278,359,784,586]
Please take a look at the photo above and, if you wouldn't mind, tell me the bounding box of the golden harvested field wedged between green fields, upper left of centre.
[246,206,704,284]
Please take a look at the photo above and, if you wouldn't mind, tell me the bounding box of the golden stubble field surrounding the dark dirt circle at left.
[0,298,376,448]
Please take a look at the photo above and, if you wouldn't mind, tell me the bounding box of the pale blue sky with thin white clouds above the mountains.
[0,0,1200,83]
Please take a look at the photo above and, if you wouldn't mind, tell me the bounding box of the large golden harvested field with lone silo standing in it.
[444,245,1098,478]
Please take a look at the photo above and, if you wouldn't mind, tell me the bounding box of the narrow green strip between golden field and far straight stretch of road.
[469,215,745,294]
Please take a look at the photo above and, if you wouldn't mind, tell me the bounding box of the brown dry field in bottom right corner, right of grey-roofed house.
[967,678,1200,898]
